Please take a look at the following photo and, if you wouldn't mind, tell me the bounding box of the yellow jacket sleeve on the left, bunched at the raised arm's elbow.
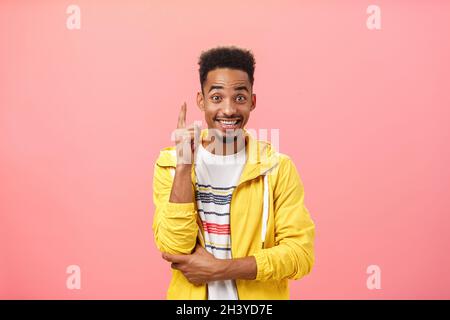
[153,164,198,254]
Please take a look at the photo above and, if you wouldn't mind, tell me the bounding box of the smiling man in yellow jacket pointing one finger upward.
[153,47,315,300]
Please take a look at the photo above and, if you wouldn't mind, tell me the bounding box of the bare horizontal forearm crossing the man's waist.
[213,256,257,280]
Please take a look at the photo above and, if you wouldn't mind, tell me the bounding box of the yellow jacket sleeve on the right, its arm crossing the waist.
[254,155,315,280]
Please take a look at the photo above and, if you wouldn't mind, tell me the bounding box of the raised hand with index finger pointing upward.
[175,102,201,166]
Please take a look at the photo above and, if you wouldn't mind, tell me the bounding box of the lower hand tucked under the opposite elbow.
[162,244,220,285]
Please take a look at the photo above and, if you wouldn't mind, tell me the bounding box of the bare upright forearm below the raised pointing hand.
[169,164,194,203]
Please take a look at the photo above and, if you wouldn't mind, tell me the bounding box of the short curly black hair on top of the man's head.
[198,46,255,90]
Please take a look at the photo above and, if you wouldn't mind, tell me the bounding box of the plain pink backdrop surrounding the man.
[0,0,450,299]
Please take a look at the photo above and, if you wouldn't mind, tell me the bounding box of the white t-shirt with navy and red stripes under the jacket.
[195,143,245,300]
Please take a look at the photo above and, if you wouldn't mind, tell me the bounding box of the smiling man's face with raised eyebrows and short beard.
[197,68,256,142]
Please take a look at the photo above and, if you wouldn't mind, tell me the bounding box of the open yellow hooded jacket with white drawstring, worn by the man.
[153,129,315,300]
